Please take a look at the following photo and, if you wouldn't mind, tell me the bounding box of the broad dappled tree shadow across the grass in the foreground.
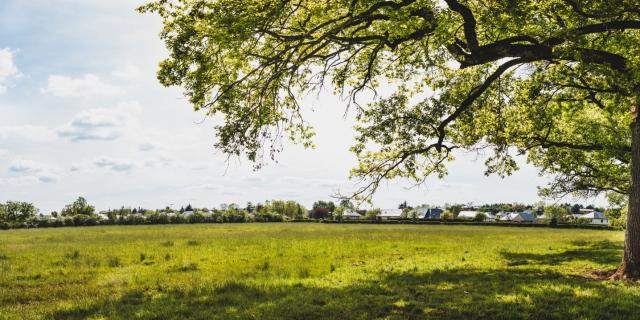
[51,269,640,319]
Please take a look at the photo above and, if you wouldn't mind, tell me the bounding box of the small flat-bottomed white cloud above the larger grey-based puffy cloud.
[40,74,124,97]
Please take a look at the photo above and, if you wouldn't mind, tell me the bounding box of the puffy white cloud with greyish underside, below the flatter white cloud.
[58,102,140,142]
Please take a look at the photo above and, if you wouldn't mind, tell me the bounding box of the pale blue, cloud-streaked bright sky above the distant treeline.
[0,0,592,212]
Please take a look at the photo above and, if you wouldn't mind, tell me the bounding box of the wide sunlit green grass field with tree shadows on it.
[0,224,640,319]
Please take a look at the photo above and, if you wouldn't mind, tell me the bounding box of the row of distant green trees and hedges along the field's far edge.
[0,197,626,229]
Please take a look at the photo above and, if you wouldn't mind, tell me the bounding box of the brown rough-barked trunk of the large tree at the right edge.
[612,101,640,280]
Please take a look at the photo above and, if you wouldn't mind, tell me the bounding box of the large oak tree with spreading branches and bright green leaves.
[141,0,640,278]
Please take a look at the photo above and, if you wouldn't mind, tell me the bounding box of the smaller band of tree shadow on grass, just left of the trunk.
[501,240,623,266]
